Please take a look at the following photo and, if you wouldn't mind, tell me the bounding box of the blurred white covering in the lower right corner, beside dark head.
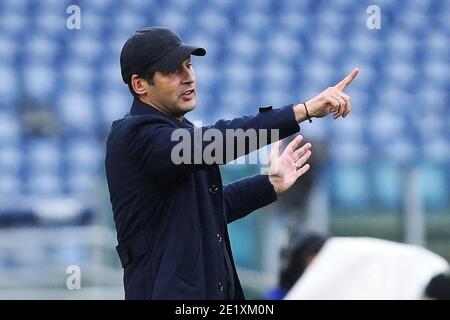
[285,237,449,300]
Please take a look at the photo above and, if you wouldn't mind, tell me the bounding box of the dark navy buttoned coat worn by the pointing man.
[105,99,299,299]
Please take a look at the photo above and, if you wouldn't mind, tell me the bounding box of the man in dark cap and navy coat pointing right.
[105,27,358,299]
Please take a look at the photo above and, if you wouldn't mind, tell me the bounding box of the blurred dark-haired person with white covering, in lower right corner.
[274,226,450,300]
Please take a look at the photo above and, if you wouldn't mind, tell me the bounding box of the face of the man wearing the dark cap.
[147,57,197,117]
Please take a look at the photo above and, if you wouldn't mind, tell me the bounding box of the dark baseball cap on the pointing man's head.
[120,27,206,83]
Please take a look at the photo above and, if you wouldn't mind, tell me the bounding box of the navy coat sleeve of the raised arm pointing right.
[128,105,299,179]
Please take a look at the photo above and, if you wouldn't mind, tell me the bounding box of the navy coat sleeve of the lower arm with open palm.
[223,175,277,223]
